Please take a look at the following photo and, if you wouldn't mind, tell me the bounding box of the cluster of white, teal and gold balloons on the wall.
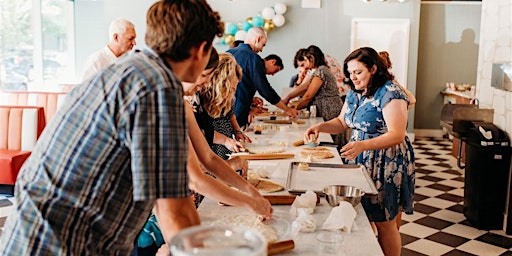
[221,3,286,45]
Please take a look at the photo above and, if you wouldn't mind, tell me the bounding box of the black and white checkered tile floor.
[0,137,512,256]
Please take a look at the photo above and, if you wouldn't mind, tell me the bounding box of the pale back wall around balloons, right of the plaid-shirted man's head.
[208,0,420,131]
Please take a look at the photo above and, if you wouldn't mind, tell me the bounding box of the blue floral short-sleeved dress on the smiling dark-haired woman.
[344,81,415,222]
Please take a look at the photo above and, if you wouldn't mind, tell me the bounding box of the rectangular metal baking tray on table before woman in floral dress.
[285,162,377,195]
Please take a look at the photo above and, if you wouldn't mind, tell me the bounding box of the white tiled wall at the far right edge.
[477,0,512,138]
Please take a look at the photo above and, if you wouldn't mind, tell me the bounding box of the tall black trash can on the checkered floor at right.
[463,121,511,230]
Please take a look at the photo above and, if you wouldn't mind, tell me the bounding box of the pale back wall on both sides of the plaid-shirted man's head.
[76,0,420,130]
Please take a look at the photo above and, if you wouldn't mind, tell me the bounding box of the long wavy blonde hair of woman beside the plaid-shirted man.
[199,52,242,118]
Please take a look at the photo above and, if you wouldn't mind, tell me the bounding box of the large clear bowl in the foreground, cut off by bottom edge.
[169,226,267,256]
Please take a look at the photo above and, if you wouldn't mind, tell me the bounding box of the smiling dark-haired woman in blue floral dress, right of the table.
[304,47,415,256]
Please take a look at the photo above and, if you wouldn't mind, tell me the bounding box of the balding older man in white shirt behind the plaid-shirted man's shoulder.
[82,18,137,80]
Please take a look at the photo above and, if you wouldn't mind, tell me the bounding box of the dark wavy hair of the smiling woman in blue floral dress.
[343,47,394,97]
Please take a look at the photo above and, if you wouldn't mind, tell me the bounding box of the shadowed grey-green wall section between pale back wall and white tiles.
[414,2,482,130]
